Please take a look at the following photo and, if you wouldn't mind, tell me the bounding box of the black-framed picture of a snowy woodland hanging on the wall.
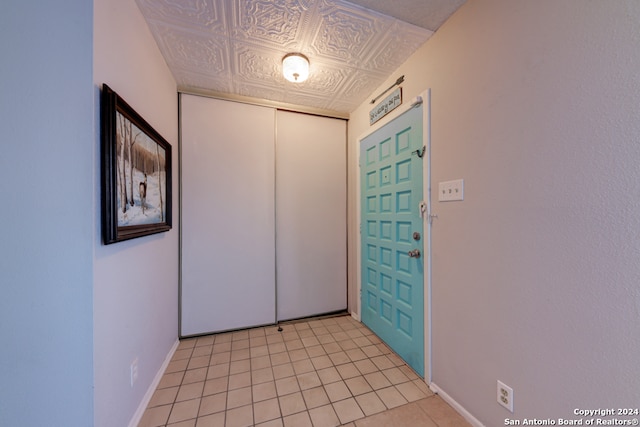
[100,84,171,245]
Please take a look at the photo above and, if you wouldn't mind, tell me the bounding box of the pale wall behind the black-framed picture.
[92,0,179,427]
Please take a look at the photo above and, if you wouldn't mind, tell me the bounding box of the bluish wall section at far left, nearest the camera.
[0,0,95,427]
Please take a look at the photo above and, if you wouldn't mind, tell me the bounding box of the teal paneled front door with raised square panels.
[360,106,425,376]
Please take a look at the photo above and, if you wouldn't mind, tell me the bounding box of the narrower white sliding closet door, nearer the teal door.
[276,111,347,320]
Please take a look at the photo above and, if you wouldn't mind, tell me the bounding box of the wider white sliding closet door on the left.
[180,94,276,336]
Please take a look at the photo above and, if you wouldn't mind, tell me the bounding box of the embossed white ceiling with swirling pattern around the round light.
[136,0,466,116]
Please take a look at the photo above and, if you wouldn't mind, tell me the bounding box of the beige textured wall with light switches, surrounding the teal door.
[349,0,640,426]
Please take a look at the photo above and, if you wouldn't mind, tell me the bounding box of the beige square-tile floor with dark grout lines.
[139,316,469,427]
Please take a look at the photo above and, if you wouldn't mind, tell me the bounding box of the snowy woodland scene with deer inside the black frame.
[116,113,166,227]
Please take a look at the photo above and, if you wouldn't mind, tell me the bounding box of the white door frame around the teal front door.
[354,89,432,385]
